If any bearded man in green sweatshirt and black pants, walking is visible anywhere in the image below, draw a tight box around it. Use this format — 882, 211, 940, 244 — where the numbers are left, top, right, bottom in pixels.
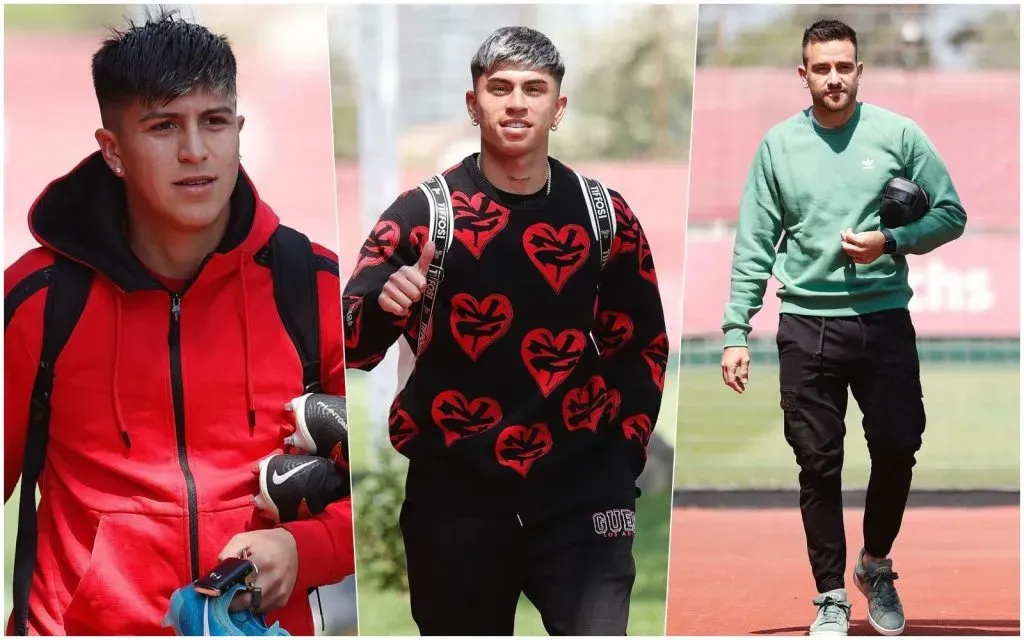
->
722, 20, 967, 635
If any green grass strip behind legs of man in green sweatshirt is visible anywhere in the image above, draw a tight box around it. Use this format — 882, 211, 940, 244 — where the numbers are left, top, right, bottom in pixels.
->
676, 362, 1020, 489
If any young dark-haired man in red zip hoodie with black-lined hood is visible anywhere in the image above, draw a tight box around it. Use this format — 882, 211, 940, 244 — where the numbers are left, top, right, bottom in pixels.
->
4, 14, 354, 635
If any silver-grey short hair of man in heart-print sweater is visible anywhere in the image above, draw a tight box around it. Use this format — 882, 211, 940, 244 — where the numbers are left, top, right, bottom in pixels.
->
469, 27, 565, 86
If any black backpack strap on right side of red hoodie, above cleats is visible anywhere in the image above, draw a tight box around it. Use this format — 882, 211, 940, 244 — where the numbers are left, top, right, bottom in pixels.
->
268, 224, 324, 393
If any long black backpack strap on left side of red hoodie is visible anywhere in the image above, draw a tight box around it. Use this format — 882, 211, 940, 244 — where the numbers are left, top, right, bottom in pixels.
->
13, 256, 92, 636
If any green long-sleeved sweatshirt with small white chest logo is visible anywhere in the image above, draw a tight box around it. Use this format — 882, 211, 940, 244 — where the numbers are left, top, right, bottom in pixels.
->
722, 102, 967, 347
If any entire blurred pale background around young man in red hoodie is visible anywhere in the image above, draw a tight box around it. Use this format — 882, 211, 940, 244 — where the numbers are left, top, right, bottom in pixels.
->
3, 4, 355, 635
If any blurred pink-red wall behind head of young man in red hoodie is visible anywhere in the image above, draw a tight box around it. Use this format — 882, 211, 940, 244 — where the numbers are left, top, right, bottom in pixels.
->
3, 33, 338, 265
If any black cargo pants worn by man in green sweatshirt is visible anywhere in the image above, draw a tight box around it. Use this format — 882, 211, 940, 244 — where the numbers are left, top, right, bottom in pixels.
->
778, 309, 925, 592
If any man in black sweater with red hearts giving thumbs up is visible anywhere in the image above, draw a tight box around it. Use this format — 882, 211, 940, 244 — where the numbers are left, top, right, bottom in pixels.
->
343, 28, 669, 635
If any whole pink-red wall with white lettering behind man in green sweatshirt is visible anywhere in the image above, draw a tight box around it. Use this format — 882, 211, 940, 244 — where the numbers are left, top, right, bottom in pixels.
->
683, 69, 1020, 338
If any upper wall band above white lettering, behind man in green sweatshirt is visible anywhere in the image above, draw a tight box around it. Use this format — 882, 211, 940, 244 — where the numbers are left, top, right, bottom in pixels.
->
689, 69, 1021, 231
